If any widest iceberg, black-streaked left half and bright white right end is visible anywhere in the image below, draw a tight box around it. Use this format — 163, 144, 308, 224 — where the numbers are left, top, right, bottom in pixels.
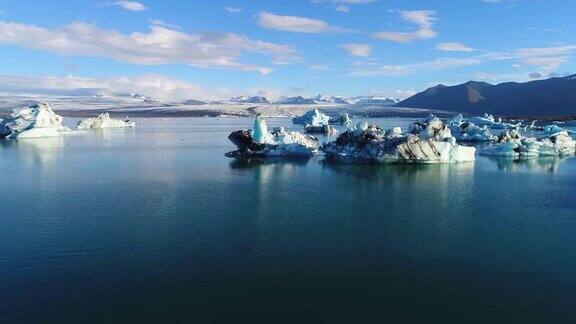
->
322, 116, 476, 164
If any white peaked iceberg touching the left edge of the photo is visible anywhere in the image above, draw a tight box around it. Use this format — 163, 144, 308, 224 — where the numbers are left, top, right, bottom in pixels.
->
0, 103, 69, 138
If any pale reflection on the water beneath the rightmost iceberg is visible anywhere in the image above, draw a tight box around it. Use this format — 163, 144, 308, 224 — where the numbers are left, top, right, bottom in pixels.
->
488, 156, 569, 173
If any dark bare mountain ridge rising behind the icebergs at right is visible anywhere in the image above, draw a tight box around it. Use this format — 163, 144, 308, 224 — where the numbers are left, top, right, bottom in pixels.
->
396, 75, 576, 116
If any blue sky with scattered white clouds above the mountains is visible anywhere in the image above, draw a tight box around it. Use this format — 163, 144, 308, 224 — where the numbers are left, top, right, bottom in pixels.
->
0, 0, 576, 100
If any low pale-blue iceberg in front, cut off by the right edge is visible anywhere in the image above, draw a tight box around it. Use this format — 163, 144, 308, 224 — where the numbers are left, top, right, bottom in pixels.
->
481, 129, 576, 158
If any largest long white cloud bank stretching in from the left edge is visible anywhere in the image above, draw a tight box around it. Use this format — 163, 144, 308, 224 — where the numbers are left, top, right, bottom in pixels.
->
0, 21, 299, 74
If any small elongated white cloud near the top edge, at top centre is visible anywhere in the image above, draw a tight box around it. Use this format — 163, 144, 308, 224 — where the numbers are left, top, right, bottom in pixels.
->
258, 12, 346, 34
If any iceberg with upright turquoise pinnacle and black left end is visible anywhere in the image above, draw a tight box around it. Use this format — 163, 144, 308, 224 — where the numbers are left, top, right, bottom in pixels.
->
226, 115, 319, 157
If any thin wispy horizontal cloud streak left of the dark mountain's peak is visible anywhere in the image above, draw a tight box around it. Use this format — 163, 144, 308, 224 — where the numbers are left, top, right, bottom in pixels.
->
350, 58, 481, 76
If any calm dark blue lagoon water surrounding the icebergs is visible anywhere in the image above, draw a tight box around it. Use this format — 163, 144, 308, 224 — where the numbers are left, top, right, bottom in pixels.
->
0, 118, 576, 323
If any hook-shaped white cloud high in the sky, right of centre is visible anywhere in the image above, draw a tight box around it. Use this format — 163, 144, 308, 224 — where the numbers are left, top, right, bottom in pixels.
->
372, 10, 438, 43
